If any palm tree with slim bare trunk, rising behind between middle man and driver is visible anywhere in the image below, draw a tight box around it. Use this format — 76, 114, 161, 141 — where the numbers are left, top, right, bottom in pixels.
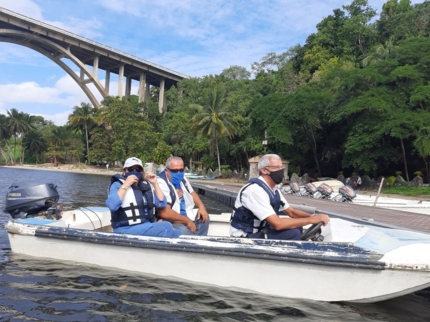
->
191, 87, 237, 173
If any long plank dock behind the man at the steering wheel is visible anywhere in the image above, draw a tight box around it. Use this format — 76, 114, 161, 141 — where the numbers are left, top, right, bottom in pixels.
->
190, 180, 430, 234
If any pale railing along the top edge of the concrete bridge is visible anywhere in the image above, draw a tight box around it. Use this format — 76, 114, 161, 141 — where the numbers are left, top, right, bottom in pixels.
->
0, 7, 189, 78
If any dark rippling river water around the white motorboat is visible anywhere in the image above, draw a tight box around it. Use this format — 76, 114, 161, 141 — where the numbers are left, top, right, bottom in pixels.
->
0, 168, 430, 322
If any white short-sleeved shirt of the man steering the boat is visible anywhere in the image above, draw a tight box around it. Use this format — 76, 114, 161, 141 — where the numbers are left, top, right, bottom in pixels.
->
230, 176, 290, 237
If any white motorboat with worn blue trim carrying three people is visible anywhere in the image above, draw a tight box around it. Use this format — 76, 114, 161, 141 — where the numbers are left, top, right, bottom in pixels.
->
6, 181, 430, 303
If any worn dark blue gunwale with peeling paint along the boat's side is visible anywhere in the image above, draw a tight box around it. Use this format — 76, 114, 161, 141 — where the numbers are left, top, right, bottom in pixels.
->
6, 220, 386, 270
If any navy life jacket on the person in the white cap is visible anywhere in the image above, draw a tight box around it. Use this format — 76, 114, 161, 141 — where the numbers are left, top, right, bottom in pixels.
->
109, 174, 155, 228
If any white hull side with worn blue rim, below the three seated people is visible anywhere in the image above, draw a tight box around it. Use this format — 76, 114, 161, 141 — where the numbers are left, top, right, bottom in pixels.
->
6, 222, 430, 303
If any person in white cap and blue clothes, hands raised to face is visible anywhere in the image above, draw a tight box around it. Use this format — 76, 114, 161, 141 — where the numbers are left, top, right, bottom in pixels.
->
106, 157, 182, 238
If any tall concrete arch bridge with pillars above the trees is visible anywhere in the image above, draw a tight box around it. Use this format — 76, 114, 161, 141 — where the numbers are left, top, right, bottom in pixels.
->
0, 7, 188, 113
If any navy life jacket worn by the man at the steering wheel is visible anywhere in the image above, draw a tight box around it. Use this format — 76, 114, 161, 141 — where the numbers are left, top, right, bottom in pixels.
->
230, 178, 285, 234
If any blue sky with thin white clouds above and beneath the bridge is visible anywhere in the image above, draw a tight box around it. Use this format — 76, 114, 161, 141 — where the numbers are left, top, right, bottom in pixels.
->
0, 0, 422, 125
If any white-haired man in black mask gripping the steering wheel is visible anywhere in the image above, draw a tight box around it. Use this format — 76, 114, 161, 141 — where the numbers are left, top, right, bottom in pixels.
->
230, 154, 330, 240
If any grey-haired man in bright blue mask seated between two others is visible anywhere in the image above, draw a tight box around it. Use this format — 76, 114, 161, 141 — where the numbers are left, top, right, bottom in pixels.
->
157, 157, 209, 236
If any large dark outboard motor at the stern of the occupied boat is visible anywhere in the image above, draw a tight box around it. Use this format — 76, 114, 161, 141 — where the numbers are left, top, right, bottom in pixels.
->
5, 181, 60, 219
